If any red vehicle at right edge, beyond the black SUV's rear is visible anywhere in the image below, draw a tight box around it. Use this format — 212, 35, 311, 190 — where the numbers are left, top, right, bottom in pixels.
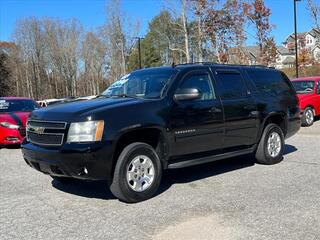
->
292, 76, 320, 126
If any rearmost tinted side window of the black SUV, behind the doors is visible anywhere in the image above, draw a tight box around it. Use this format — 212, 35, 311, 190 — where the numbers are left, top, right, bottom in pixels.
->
247, 69, 291, 94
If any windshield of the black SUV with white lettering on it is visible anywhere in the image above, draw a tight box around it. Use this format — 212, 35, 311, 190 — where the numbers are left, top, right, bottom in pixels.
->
101, 69, 177, 98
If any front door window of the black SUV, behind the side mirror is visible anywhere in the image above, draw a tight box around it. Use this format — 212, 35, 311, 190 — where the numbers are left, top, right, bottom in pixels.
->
179, 74, 215, 100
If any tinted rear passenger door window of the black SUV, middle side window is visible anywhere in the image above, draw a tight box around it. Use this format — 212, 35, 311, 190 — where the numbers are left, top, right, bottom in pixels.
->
217, 72, 247, 99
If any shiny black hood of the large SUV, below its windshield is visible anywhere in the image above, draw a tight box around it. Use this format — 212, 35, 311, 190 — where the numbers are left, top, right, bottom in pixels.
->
31, 97, 144, 122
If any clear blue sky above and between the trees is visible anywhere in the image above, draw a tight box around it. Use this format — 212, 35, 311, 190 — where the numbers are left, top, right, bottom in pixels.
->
0, 0, 320, 45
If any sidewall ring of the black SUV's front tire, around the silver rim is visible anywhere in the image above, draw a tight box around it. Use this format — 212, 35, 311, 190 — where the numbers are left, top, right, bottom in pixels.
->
116, 143, 162, 202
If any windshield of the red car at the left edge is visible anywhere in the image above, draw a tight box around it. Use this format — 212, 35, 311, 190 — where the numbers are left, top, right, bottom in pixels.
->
0, 99, 38, 113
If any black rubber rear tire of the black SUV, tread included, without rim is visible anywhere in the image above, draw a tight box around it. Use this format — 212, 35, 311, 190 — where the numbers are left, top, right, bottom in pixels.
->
255, 123, 284, 165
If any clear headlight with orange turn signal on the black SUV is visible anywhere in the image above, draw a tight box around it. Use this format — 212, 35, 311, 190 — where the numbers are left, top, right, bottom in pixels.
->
67, 121, 104, 143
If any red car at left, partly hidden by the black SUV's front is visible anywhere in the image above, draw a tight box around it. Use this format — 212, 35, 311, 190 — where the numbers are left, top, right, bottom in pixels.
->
0, 97, 39, 146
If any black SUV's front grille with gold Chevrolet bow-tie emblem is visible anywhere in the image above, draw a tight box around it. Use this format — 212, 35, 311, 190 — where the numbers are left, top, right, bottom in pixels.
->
27, 120, 67, 146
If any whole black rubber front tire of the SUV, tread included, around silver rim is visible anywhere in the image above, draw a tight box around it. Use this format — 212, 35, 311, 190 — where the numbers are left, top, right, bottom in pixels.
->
110, 142, 162, 203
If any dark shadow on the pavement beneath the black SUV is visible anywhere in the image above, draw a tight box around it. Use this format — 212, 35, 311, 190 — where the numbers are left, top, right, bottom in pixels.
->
51, 144, 297, 200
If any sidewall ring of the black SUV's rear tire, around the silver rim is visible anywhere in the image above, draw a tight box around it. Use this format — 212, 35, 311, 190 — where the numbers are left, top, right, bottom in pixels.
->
263, 124, 284, 164
